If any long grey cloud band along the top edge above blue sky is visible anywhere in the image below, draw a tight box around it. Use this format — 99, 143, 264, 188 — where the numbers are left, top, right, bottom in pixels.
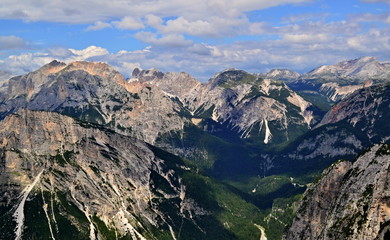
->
0, 0, 311, 24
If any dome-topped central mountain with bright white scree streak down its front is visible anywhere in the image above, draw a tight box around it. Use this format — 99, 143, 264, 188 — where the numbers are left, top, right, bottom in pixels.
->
185, 69, 314, 144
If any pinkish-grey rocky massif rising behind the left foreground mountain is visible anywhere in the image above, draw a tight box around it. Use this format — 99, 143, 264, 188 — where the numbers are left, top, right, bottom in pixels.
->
0, 62, 189, 143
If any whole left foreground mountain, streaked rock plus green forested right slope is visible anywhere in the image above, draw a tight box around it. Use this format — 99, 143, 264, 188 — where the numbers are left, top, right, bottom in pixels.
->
0, 110, 261, 240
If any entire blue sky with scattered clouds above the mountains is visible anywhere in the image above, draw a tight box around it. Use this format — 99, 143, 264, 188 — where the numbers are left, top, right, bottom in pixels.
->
0, 0, 390, 81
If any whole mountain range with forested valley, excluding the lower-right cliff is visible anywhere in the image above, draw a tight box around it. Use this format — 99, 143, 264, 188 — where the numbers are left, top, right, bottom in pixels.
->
0, 57, 390, 239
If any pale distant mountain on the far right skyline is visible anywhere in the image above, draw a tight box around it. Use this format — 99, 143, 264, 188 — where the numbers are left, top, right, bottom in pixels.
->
288, 57, 390, 103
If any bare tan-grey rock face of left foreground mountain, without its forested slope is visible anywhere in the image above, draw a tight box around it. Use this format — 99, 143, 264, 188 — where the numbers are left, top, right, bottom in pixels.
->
0, 110, 203, 239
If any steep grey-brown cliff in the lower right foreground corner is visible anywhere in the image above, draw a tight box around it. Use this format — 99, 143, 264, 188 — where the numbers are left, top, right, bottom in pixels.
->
285, 144, 390, 239
